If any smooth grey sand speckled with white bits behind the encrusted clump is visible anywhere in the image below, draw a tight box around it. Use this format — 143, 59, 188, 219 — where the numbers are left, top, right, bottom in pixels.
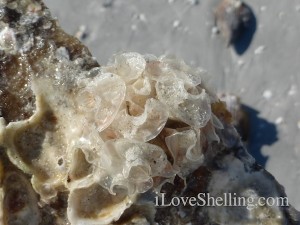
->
46, 0, 300, 210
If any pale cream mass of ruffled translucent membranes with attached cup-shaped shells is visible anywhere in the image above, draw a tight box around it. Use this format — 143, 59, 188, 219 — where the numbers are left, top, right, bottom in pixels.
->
2, 50, 222, 224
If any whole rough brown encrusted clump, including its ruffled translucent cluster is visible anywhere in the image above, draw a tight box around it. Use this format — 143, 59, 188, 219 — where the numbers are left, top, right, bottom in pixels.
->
0, 0, 300, 225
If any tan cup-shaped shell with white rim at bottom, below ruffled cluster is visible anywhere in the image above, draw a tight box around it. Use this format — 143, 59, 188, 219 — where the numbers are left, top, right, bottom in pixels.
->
67, 184, 135, 225
